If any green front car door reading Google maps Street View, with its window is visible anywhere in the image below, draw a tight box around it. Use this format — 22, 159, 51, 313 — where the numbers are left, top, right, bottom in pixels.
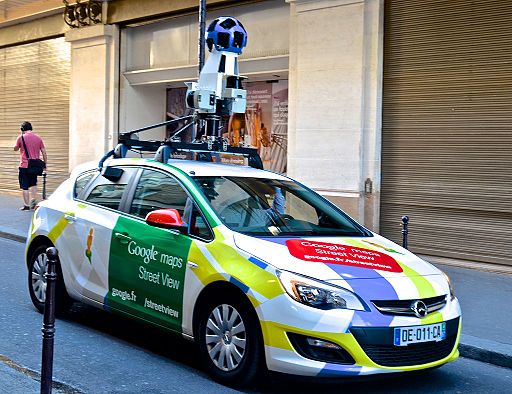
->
108, 169, 192, 332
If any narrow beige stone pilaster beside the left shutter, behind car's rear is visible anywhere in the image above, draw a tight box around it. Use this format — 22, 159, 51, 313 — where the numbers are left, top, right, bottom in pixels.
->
66, 25, 119, 170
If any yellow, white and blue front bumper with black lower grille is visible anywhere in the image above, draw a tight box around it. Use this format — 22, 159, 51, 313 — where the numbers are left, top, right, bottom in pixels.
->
261, 300, 461, 377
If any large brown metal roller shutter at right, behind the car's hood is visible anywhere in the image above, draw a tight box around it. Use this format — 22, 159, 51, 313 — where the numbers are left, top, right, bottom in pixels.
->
381, 0, 512, 265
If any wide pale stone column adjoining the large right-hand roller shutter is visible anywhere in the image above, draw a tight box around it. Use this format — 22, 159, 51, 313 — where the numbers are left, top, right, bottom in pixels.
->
287, 0, 383, 229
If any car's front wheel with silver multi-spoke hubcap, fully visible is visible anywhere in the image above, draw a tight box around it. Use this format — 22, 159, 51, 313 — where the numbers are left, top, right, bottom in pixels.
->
197, 294, 264, 387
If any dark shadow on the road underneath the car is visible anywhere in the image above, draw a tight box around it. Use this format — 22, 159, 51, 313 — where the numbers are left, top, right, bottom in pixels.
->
59, 303, 456, 394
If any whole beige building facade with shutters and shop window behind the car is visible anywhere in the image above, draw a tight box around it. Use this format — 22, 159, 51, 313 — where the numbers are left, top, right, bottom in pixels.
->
0, 0, 512, 265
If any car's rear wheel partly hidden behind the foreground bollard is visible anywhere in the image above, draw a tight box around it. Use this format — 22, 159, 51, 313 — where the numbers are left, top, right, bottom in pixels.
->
28, 244, 73, 315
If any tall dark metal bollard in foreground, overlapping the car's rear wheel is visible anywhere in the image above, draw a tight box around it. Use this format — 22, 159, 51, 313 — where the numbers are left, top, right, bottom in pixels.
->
41, 247, 59, 394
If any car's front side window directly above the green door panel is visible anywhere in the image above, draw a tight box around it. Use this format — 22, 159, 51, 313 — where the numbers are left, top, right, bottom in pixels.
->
129, 169, 188, 222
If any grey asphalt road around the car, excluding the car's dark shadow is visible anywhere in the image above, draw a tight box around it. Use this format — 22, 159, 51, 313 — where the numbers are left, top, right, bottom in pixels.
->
0, 239, 512, 393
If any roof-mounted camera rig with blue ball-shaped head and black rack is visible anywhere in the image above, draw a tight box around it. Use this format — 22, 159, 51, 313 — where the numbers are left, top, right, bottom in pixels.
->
99, 17, 263, 169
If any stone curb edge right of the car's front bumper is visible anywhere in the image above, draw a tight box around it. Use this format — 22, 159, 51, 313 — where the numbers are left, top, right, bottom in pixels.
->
459, 334, 512, 369
